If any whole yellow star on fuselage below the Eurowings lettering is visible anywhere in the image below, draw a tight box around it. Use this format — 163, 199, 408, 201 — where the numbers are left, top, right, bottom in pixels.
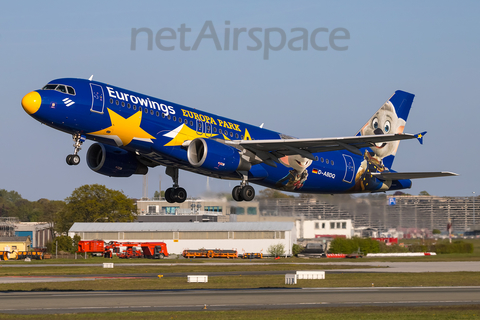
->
89, 109, 155, 146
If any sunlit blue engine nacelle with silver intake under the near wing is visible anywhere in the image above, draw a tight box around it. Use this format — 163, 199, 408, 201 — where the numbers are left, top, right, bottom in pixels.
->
187, 138, 252, 173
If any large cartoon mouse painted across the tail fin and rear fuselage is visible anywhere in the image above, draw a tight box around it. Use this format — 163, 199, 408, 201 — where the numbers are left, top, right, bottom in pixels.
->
354, 101, 405, 191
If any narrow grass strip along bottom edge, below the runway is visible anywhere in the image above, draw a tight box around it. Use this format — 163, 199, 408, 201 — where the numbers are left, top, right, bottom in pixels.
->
0, 305, 480, 320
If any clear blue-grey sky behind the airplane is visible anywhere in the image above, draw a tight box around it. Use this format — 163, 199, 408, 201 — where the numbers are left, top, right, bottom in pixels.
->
0, 1, 480, 201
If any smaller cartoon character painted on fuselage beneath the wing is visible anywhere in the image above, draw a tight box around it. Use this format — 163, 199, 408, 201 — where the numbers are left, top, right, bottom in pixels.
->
275, 154, 312, 191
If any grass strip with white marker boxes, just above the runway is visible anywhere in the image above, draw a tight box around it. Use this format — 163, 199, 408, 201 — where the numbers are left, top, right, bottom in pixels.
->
1, 272, 480, 291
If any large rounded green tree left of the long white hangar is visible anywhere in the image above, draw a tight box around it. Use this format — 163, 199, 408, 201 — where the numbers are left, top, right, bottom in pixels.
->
55, 184, 135, 233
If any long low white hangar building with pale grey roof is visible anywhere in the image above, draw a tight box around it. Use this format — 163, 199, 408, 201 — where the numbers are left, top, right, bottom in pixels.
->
68, 222, 297, 255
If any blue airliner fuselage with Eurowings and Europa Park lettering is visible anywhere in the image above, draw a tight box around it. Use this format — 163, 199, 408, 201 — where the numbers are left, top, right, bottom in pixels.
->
23, 78, 411, 193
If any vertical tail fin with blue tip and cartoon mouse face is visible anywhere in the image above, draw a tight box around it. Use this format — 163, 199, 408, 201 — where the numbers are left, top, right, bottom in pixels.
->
357, 90, 415, 169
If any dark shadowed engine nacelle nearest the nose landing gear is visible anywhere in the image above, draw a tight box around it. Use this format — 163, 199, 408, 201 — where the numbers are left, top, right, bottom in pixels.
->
87, 143, 148, 177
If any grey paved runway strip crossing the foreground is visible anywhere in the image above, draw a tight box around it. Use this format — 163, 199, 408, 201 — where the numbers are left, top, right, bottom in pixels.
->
0, 287, 480, 314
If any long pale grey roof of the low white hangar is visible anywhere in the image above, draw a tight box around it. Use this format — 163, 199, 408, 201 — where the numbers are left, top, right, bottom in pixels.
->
69, 222, 294, 232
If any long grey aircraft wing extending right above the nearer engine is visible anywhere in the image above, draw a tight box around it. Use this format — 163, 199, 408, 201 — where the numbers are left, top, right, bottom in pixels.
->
226, 133, 418, 167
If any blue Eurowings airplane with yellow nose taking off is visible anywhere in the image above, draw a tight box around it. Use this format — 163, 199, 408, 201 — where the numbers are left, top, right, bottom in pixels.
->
22, 76, 456, 203
